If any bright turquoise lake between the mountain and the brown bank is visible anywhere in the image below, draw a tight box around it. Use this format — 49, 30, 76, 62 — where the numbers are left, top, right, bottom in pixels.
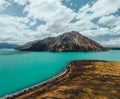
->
0, 49, 120, 97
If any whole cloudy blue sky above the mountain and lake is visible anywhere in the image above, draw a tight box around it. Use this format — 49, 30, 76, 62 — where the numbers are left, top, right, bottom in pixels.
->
0, 0, 120, 46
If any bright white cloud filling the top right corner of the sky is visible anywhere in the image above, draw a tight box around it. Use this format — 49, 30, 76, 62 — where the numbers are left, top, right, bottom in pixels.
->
90, 0, 120, 17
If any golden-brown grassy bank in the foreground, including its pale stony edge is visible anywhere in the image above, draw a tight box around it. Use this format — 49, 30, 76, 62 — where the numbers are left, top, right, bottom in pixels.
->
3, 60, 120, 99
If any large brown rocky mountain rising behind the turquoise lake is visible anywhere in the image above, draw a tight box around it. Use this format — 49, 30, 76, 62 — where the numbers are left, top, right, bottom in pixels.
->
17, 31, 108, 52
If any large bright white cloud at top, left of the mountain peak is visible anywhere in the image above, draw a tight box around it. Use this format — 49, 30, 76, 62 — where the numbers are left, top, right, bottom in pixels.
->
24, 0, 76, 37
